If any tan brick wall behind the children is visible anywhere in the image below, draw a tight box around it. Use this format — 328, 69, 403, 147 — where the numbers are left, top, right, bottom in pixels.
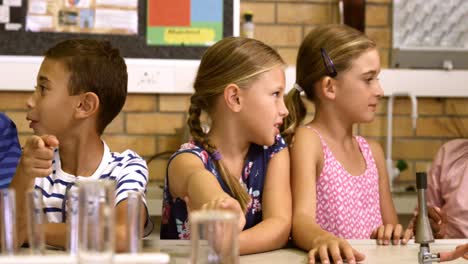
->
0, 0, 468, 187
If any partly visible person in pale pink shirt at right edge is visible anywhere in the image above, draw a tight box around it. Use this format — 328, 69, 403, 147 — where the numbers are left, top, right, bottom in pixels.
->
403, 139, 468, 242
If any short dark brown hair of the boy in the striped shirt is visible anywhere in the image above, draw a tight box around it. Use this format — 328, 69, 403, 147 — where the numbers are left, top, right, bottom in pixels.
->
44, 39, 128, 134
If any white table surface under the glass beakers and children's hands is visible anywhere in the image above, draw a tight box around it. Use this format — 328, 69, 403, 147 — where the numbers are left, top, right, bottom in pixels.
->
0, 239, 468, 264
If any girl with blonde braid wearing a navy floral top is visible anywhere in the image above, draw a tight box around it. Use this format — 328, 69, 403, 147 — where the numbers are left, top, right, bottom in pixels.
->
161, 37, 291, 254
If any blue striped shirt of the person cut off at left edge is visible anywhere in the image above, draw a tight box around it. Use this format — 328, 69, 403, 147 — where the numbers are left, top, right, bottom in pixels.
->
0, 113, 21, 189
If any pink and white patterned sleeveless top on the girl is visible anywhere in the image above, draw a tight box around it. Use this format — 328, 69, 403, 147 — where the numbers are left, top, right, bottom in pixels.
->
309, 127, 382, 239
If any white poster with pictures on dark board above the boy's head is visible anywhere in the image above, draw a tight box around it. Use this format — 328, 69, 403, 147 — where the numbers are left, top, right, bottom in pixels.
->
26, 0, 138, 35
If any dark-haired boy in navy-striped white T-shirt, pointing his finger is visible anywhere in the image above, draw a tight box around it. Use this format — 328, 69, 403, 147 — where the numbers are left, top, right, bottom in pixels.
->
11, 39, 152, 251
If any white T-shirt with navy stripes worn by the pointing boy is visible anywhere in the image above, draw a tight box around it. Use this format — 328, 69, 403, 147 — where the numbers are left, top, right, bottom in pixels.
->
35, 143, 153, 235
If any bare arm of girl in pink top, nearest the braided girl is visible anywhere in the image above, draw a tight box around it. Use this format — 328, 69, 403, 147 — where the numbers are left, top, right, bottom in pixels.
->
290, 127, 364, 263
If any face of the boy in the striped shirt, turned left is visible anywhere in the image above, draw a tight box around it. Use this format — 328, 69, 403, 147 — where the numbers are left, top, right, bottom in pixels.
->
26, 58, 79, 136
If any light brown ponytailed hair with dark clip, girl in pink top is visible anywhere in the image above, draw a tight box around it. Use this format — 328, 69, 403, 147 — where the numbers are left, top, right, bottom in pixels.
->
282, 24, 376, 142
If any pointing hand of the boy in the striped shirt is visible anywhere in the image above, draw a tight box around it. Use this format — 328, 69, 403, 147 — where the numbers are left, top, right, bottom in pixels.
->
19, 135, 59, 178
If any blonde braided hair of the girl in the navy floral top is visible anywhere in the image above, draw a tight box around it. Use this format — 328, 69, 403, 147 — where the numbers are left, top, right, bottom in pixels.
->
187, 37, 284, 210
